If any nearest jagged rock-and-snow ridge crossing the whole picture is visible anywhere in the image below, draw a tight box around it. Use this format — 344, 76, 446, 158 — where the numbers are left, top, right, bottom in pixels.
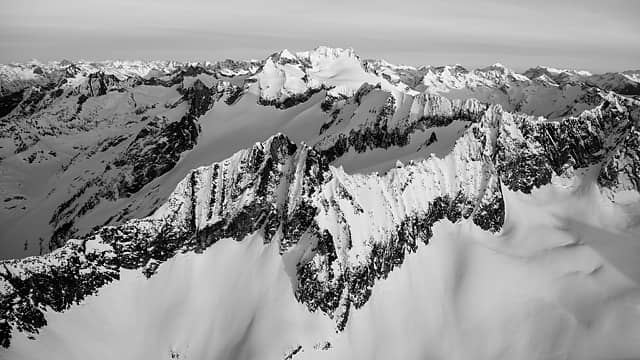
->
0, 95, 640, 347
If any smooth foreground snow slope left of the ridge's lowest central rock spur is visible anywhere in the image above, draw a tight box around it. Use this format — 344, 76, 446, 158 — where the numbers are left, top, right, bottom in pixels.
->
0, 235, 333, 360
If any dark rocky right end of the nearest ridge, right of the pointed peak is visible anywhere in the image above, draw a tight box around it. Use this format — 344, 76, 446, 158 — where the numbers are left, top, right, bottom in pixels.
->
497, 96, 638, 193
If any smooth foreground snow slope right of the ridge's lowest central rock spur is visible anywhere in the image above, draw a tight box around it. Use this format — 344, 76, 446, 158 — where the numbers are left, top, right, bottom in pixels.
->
308, 181, 640, 360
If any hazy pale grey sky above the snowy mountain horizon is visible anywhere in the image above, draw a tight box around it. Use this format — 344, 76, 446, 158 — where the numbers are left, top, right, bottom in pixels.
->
0, 0, 640, 71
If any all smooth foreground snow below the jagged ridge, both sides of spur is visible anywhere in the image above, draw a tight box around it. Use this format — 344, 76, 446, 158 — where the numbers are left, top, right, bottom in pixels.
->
3, 175, 640, 360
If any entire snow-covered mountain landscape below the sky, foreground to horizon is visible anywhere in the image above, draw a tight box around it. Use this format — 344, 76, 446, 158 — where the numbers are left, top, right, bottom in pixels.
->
0, 47, 640, 359
